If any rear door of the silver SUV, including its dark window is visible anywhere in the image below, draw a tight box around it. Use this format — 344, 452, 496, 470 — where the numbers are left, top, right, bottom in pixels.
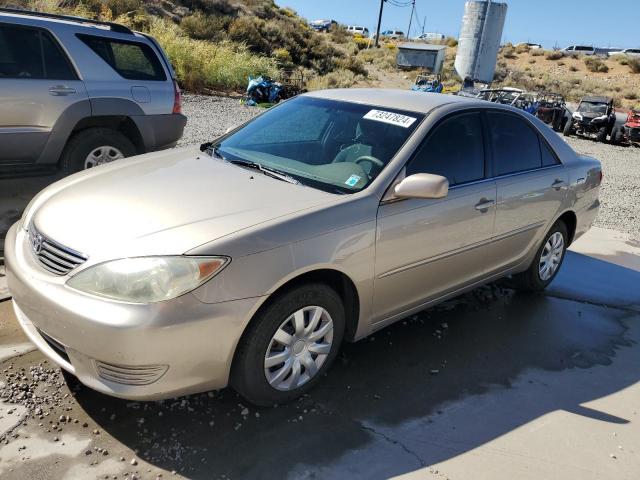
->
0, 23, 91, 165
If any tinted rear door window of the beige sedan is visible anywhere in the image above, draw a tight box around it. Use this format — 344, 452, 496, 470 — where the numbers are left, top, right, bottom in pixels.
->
487, 112, 542, 176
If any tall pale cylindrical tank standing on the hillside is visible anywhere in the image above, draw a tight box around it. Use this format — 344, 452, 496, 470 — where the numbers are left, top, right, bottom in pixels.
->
455, 1, 507, 83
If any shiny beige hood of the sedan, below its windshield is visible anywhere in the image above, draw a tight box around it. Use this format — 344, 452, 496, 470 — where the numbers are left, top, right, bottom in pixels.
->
32, 149, 339, 263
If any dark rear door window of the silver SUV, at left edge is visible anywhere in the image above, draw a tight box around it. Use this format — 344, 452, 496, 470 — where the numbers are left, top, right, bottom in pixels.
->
0, 24, 77, 80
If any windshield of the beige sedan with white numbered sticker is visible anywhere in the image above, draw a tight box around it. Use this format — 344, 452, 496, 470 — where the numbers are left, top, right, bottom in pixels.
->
214, 96, 423, 193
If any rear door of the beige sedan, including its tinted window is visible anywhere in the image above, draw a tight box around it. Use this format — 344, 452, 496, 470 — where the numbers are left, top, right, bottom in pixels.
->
485, 111, 568, 270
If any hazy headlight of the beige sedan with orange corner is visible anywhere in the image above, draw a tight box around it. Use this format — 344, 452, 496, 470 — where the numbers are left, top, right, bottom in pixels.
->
67, 256, 230, 303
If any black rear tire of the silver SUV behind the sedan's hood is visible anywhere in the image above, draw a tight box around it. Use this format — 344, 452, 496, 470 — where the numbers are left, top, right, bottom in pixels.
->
61, 128, 137, 175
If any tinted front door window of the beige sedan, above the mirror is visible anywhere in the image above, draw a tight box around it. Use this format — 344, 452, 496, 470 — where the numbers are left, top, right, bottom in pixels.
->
407, 113, 484, 185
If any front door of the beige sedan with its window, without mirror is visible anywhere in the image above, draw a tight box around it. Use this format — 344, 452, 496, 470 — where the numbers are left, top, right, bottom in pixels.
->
373, 112, 496, 323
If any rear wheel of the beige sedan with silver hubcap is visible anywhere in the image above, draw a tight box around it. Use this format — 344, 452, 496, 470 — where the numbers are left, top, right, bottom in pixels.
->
510, 220, 569, 292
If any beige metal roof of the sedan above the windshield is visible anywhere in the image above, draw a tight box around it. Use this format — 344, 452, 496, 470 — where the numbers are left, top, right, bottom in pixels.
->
304, 88, 472, 113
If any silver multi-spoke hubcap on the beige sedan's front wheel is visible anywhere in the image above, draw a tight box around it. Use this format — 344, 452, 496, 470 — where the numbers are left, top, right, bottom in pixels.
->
264, 306, 333, 391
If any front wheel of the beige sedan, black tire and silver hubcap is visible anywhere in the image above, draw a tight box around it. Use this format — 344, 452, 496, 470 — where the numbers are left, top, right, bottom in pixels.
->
230, 283, 345, 406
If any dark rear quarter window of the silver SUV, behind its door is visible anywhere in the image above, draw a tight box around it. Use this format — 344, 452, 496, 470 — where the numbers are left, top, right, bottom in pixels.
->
78, 35, 167, 81
